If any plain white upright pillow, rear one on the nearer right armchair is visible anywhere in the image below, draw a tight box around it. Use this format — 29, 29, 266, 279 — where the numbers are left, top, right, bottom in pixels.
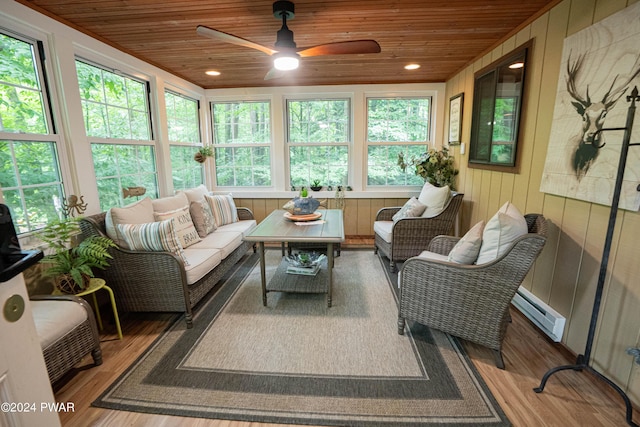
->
476, 202, 529, 264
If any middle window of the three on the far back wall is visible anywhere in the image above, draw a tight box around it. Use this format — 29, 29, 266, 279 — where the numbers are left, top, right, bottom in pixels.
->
287, 99, 351, 187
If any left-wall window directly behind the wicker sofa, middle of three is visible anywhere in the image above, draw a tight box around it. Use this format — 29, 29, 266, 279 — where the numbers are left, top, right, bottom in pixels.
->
76, 60, 158, 210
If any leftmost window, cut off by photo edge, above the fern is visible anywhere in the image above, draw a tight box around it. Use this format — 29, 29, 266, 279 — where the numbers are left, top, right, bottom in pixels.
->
0, 32, 64, 233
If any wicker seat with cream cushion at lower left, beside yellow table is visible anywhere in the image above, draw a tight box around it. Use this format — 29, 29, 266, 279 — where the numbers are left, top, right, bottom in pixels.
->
29, 295, 102, 384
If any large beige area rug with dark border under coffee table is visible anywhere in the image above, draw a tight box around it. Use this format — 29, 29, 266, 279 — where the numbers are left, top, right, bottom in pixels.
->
93, 250, 510, 426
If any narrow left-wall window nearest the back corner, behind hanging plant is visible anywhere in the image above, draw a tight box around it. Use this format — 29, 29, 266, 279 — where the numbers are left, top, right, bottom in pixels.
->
164, 90, 204, 190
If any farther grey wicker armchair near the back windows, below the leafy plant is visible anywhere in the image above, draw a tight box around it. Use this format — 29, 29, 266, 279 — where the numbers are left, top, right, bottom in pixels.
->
374, 193, 464, 272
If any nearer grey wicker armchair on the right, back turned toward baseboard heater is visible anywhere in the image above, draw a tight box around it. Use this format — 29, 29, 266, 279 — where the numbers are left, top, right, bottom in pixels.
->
398, 214, 547, 369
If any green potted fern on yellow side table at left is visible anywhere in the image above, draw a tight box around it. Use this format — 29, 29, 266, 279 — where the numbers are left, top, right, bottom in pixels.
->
37, 218, 116, 294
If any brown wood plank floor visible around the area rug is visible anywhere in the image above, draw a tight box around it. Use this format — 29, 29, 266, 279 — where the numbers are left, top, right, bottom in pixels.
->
54, 242, 640, 427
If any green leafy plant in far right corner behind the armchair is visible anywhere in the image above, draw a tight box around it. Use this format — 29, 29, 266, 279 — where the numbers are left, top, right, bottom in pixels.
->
398, 147, 458, 190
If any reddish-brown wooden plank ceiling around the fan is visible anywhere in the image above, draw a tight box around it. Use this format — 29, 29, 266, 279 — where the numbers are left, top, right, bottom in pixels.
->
17, 0, 559, 89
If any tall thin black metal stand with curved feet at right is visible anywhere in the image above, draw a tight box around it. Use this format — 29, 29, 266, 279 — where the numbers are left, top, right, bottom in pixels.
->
533, 86, 640, 427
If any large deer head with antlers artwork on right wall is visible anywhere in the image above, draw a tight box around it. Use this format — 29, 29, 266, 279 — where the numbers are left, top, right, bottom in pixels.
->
540, 3, 640, 210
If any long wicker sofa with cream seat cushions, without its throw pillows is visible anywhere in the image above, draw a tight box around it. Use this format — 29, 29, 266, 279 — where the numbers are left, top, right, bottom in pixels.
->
80, 189, 256, 328
